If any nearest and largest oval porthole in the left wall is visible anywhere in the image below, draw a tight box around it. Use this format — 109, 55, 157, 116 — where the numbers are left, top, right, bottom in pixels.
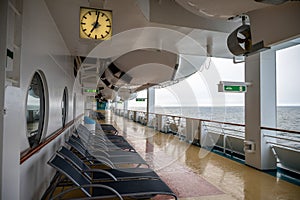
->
26, 72, 45, 148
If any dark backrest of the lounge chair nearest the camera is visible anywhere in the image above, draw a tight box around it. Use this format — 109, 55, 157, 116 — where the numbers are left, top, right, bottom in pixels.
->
48, 154, 91, 197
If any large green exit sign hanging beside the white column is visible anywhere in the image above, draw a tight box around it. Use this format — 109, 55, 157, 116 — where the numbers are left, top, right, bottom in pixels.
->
218, 81, 249, 93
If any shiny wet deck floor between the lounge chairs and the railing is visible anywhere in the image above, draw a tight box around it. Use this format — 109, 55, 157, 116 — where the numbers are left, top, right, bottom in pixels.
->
105, 113, 300, 200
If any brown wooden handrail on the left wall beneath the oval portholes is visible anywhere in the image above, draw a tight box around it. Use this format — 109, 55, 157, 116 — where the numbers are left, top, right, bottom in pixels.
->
20, 114, 83, 164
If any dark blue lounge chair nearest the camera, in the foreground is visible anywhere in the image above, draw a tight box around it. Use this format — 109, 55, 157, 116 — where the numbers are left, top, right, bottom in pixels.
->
48, 154, 177, 199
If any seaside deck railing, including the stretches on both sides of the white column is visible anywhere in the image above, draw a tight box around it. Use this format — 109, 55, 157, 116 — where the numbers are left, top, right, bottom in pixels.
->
114, 109, 300, 173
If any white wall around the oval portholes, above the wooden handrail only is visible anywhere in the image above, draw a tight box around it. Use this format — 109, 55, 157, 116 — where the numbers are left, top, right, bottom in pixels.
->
20, 0, 74, 151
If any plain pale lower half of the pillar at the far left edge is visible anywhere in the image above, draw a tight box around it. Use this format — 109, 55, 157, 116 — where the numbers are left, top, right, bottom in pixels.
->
0, 86, 22, 199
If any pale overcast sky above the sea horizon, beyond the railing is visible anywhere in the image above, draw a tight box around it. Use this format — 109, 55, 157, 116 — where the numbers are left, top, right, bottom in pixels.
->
130, 45, 300, 107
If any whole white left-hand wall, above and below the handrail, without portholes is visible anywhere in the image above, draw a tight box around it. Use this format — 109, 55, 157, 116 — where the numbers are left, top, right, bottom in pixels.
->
2, 0, 83, 199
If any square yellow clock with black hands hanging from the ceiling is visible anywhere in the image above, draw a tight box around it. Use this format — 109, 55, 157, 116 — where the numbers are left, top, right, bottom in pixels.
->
79, 7, 112, 40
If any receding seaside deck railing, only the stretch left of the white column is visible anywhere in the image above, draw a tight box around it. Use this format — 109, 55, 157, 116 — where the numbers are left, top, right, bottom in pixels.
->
114, 109, 245, 158
